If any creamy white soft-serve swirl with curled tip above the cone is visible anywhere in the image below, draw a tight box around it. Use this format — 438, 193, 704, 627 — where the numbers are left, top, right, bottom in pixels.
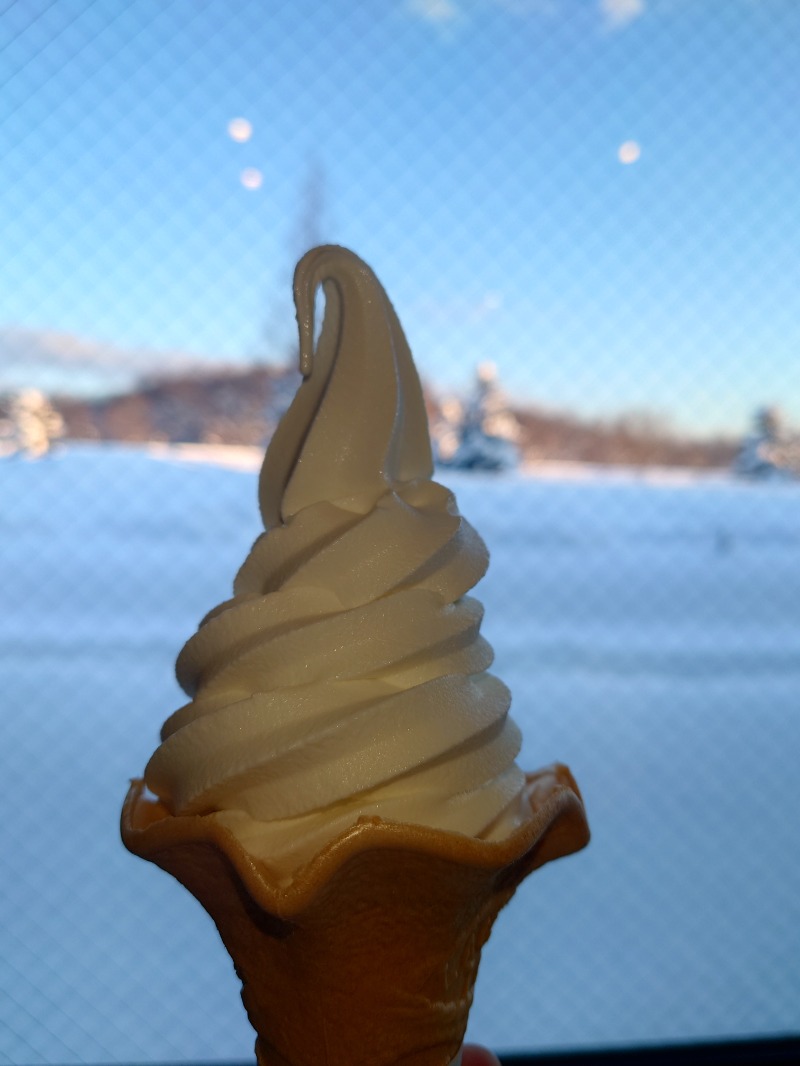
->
145, 246, 526, 876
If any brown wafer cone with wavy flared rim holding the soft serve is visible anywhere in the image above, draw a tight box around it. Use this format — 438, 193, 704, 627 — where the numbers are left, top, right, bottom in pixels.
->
122, 765, 589, 1066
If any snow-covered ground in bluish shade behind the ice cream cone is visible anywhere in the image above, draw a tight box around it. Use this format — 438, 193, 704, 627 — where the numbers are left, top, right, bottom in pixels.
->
0, 447, 800, 1064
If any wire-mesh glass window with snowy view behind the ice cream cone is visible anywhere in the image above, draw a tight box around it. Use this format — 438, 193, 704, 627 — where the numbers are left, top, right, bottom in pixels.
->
0, 0, 800, 1064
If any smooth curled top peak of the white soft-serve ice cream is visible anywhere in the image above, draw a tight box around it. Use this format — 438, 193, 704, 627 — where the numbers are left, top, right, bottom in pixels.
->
259, 245, 433, 529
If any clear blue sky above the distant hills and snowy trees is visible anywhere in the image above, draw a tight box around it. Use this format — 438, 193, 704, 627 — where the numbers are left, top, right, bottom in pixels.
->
0, 0, 800, 433
